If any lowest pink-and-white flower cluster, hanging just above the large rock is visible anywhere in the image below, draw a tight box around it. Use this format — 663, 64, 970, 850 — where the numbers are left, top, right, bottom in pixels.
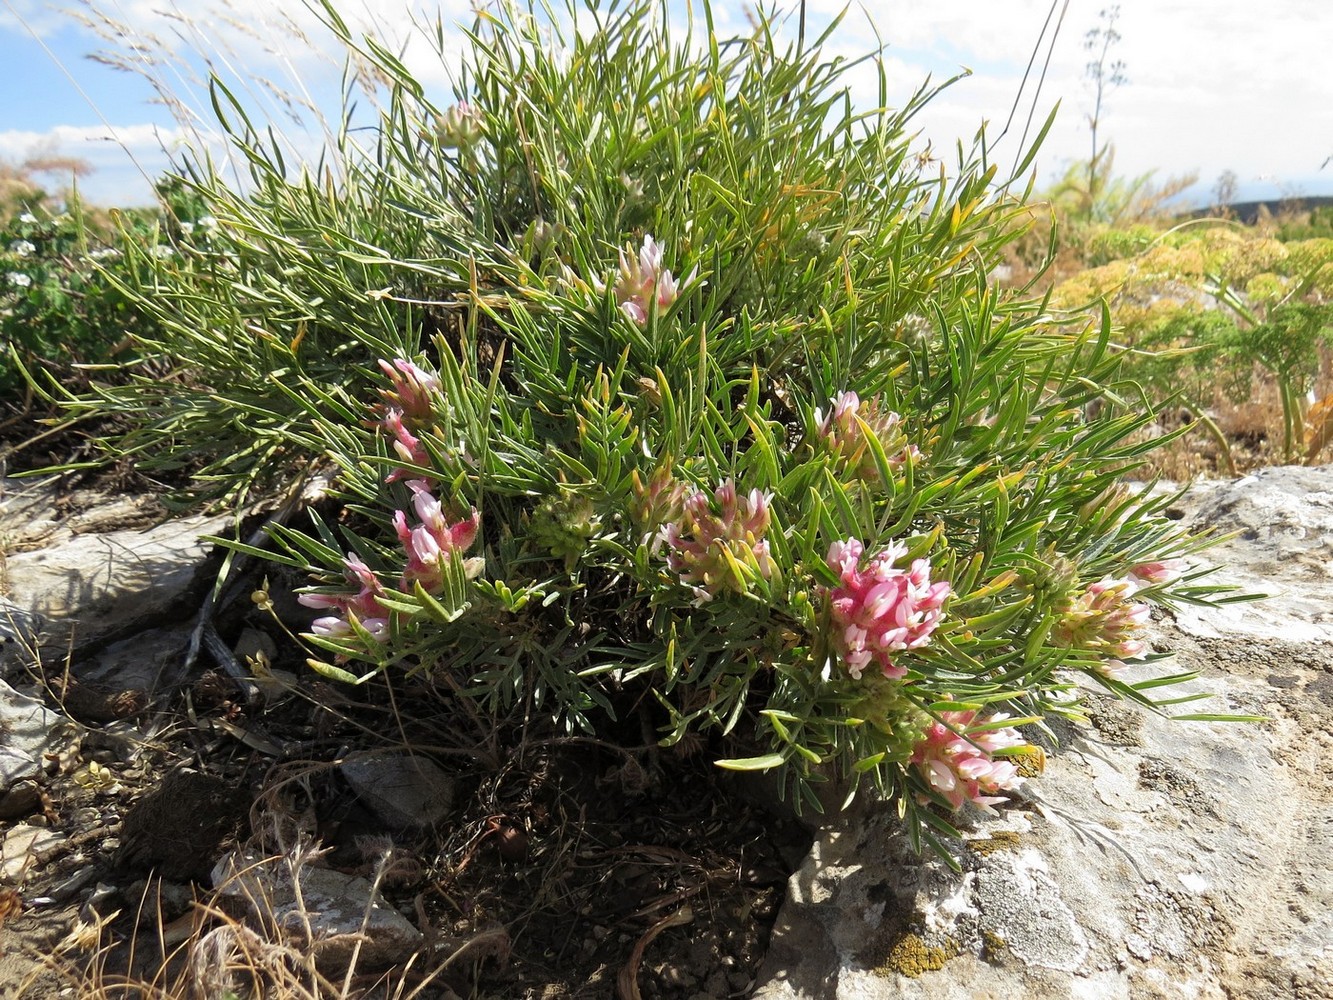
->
912, 711, 1026, 815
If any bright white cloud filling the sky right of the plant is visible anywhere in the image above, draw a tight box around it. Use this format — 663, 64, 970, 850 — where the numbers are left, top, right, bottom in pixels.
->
810, 0, 1333, 193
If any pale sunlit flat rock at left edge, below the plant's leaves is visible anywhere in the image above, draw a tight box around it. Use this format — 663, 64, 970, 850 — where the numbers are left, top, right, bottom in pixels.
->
0, 477, 228, 661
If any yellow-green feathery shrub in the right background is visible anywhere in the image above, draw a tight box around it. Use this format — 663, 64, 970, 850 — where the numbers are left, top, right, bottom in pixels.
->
1052, 221, 1333, 471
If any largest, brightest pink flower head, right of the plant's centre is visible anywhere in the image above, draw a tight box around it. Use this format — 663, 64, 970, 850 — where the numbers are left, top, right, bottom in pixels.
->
828, 539, 952, 680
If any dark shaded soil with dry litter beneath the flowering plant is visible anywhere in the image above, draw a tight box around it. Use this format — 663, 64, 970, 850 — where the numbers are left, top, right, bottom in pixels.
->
0, 498, 810, 1000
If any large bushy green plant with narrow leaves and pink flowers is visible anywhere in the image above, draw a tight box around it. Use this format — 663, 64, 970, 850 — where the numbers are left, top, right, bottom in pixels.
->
75, 1, 1247, 844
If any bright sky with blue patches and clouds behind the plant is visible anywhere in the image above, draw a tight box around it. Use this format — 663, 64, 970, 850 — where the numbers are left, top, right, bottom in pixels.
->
0, 0, 1333, 204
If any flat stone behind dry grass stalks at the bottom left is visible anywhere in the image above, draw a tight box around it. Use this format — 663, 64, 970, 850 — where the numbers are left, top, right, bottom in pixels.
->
213, 853, 423, 975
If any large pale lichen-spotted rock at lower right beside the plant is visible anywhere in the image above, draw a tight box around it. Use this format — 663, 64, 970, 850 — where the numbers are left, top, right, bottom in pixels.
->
754, 468, 1333, 1000
